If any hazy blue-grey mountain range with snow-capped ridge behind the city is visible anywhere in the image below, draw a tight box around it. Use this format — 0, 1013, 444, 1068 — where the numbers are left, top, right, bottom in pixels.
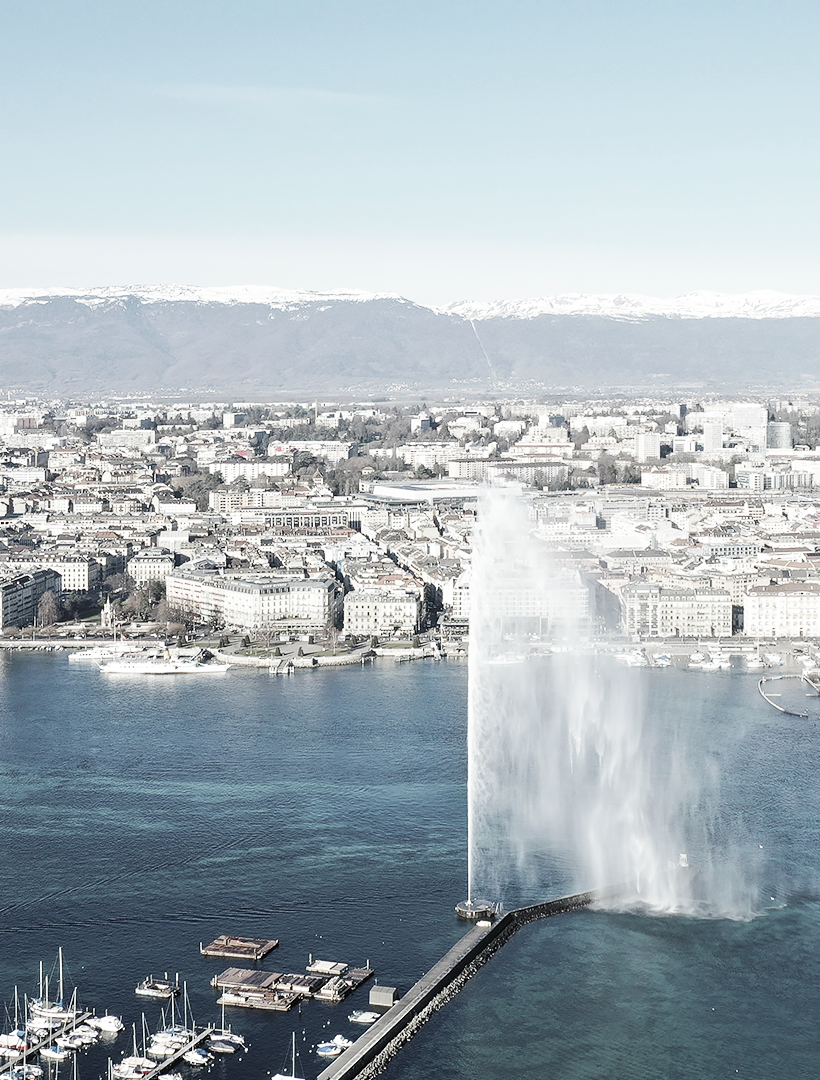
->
0, 286, 820, 396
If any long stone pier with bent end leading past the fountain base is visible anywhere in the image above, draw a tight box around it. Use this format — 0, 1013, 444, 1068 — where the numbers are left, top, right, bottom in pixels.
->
318, 887, 628, 1080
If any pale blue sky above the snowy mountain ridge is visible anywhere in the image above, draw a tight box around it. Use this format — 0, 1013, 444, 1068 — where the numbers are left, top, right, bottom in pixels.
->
0, 0, 820, 305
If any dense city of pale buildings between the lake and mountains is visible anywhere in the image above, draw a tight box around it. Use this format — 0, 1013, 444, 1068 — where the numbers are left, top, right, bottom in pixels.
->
0, 397, 820, 663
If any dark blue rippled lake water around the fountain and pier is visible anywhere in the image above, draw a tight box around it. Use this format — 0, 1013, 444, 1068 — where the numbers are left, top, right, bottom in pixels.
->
0, 653, 820, 1080
